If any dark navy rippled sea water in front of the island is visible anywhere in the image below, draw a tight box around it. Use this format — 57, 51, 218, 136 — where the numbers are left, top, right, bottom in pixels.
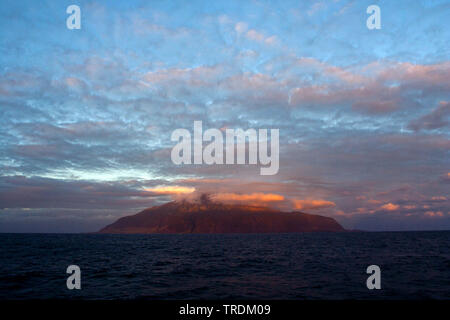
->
0, 232, 450, 299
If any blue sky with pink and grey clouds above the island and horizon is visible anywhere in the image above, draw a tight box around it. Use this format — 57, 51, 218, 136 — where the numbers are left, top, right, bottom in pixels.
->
0, 0, 450, 232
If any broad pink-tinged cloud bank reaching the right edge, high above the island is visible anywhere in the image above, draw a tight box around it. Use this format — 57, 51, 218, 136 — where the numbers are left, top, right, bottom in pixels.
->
289, 59, 450, 115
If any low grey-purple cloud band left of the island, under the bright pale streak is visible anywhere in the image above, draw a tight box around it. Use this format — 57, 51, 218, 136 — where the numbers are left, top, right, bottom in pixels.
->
0, 176, 160, 211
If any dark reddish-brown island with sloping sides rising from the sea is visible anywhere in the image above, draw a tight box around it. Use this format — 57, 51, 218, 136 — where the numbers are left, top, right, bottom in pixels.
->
98, 200, 346, 234
